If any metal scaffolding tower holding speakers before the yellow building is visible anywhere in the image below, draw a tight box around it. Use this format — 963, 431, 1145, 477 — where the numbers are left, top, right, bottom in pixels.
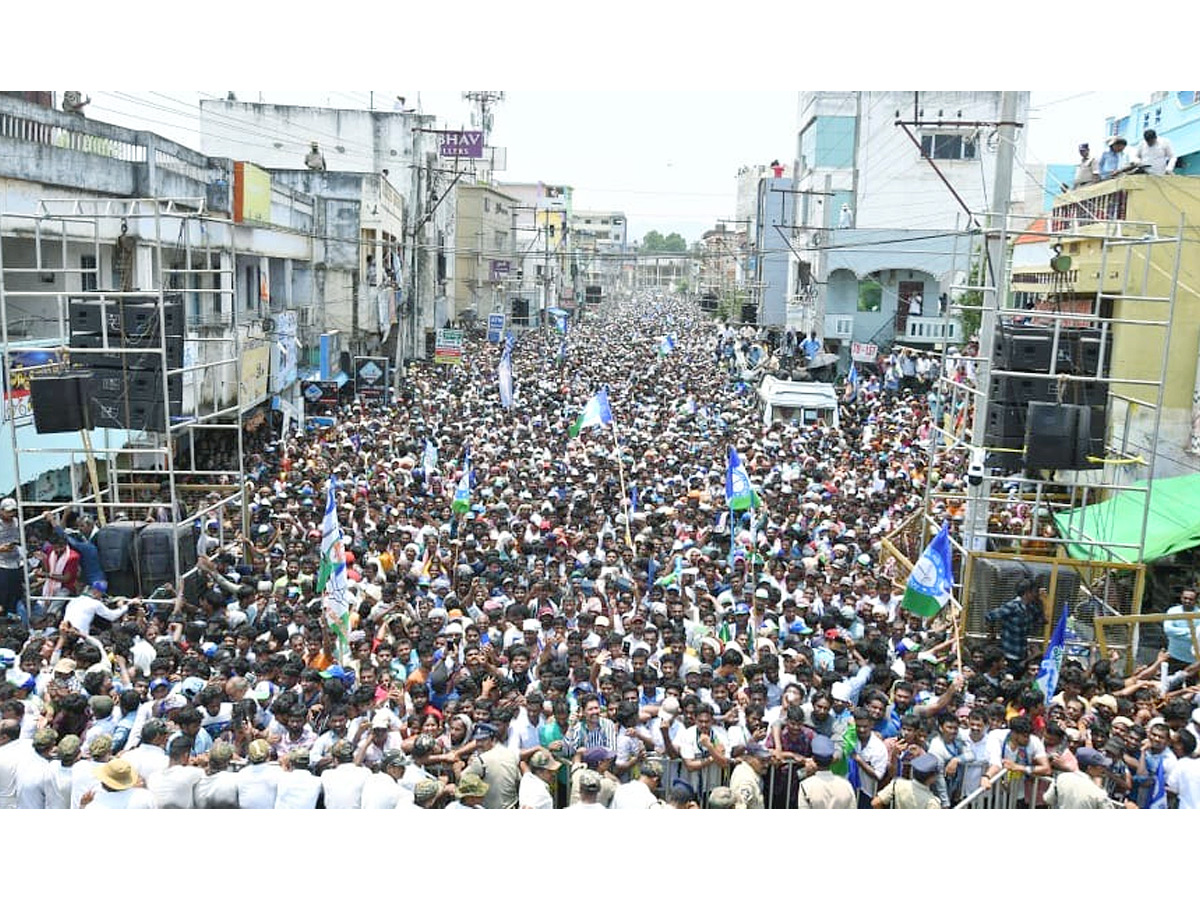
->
912, 205, 1184, 655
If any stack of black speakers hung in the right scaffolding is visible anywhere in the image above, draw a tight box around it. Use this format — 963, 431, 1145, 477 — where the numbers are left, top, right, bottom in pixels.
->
985, 324, 1110, 472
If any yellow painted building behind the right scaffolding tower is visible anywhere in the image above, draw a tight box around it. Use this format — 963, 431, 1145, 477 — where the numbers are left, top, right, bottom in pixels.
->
1010, 175, 1200, 480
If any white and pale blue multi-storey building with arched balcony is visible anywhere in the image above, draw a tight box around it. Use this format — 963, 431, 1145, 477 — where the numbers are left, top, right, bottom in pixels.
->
787, 91, 1042, 355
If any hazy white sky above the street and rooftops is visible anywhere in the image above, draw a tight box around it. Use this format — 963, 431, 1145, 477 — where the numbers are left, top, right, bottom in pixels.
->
89, 85, 1151, 241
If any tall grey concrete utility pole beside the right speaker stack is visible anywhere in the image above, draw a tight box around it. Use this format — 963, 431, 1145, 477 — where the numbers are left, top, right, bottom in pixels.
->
964, 91, 1018, 551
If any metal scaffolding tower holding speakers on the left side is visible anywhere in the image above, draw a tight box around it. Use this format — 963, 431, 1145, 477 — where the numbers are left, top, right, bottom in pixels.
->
0, 198, 246, 602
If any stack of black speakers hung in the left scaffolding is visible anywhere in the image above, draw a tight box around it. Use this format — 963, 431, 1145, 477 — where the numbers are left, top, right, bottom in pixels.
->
32, 298, 184, 433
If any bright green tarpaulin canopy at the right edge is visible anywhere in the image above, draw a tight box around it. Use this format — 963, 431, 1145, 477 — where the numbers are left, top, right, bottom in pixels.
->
1054, 474, 1200, 563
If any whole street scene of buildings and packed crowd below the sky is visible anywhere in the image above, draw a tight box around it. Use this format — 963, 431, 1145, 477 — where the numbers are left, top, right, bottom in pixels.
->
0, 91, 1200, 809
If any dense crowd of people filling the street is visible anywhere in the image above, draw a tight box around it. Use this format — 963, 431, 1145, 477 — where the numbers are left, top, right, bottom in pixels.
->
0, 295, 1200, 810
